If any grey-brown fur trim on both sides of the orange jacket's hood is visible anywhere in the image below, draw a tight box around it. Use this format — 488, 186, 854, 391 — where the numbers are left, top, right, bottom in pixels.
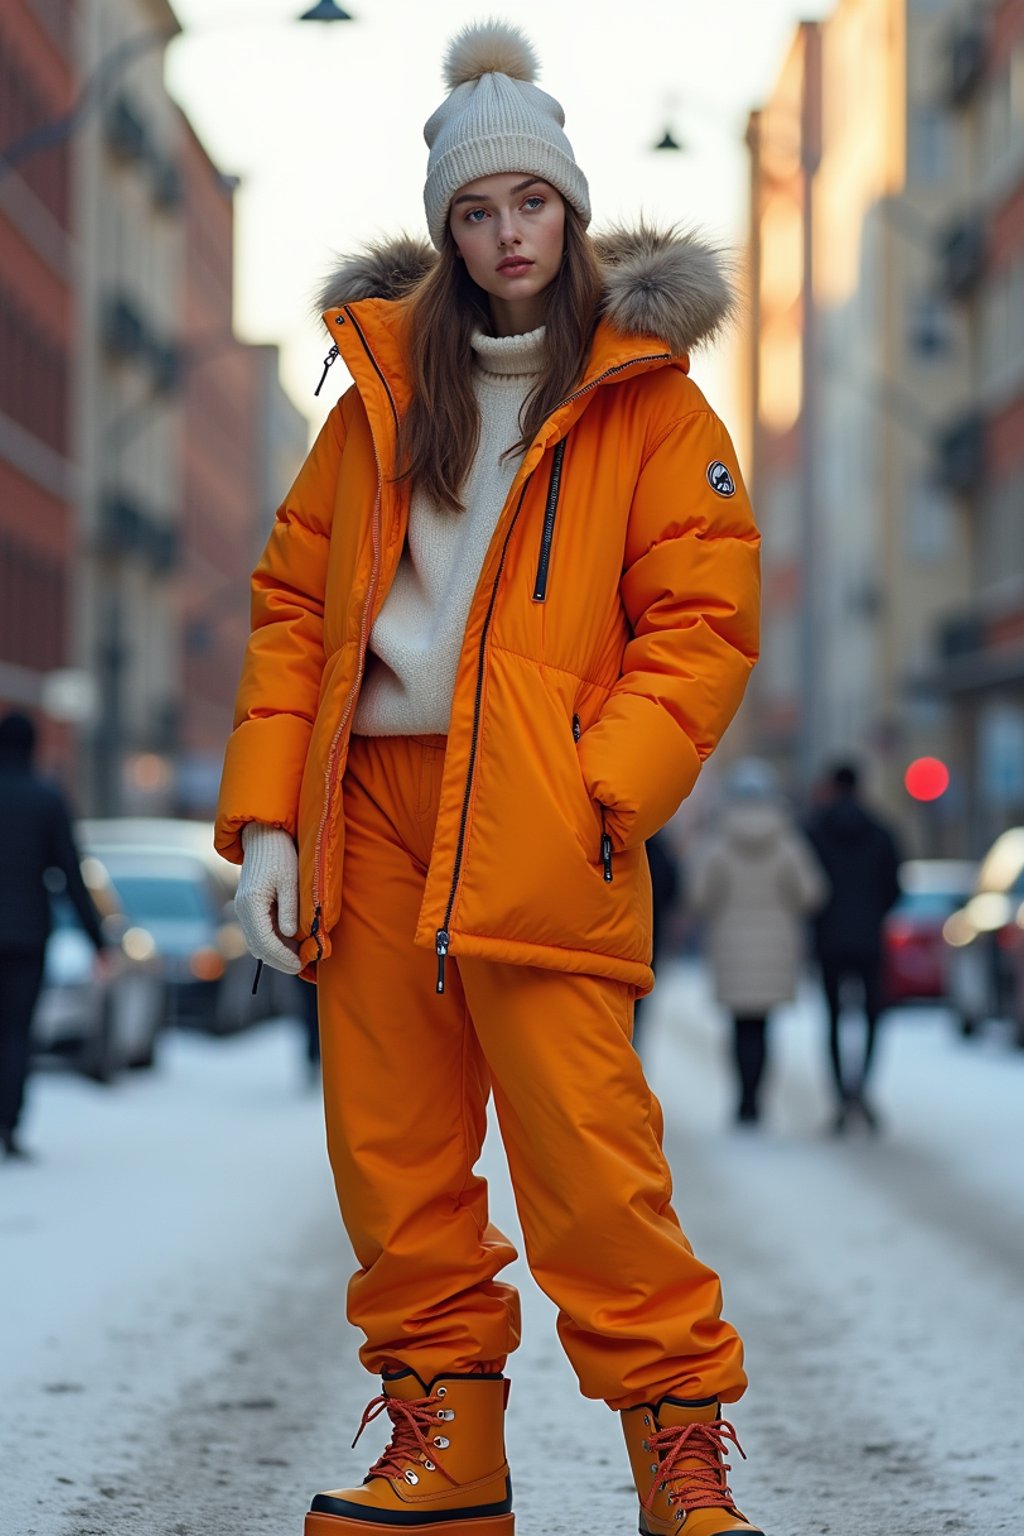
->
319, 224, 735, 356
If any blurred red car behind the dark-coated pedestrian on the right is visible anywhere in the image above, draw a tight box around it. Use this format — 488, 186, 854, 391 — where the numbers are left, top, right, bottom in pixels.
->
883, 859, 976, 1008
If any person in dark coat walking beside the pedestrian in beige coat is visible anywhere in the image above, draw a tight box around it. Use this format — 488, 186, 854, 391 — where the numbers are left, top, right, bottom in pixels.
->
808, 763, 900, 1130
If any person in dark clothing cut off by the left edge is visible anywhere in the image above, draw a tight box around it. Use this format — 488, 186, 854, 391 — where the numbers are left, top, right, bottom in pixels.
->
0, 713, 104, 1157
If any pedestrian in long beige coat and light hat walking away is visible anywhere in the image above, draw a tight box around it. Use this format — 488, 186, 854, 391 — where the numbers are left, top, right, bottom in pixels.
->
691, 757, 827, 1124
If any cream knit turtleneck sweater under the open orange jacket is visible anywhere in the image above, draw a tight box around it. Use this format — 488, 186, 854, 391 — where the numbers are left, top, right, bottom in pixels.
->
352, 326, 545, 736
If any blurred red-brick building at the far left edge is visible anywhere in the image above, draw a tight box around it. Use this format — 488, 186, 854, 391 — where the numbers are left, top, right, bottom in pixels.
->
0, 0, 77, 780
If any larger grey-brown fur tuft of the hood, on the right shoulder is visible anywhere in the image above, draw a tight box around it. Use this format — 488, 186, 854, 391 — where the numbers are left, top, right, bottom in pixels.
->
594, 224, 735, 353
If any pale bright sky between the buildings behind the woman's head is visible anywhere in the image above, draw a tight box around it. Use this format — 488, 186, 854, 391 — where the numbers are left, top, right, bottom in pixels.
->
167, 0, 832, 421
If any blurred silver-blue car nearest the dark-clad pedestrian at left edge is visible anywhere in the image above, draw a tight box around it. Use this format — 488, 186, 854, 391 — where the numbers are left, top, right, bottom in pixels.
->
32, 857, 164, 1083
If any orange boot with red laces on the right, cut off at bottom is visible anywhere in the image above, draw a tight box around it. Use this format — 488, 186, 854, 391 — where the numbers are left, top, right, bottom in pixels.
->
622, 1398, 763, 1536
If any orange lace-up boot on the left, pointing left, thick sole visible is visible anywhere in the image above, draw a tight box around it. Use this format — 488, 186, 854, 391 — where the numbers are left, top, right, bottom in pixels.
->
306, 1370, 514, 1536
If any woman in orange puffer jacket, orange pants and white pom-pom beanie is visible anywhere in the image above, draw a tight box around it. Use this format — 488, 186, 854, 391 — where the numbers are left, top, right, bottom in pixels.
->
216, 23, 758, 1536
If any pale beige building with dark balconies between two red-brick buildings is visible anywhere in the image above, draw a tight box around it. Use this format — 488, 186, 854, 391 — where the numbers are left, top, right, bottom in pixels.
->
74, 0, 184, 813
